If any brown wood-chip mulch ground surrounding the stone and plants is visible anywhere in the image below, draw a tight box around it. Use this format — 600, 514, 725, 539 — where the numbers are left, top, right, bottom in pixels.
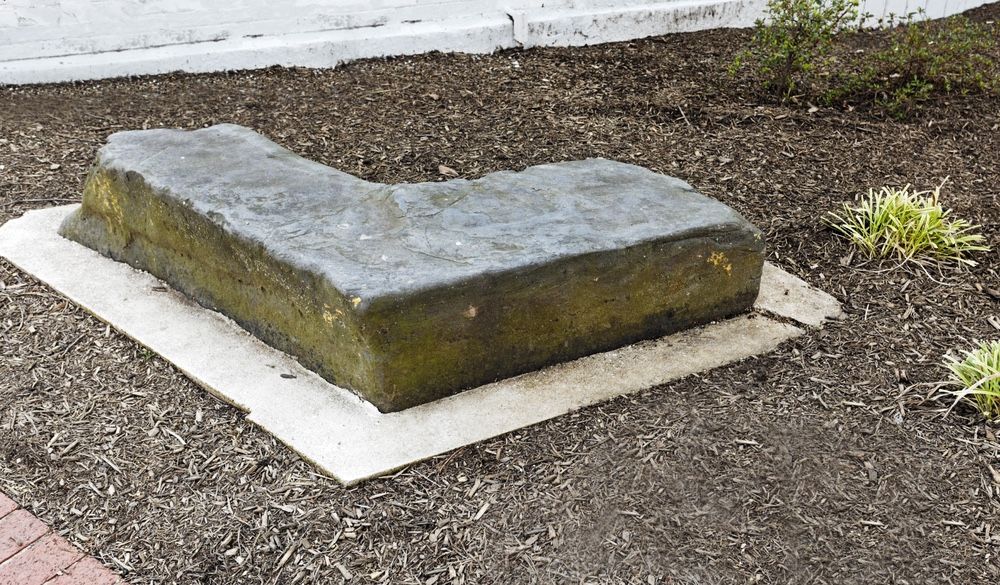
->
0, 5, 1000, 585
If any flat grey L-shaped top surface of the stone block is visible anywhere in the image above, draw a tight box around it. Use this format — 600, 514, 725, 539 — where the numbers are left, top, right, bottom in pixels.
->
99, 124, 756, 310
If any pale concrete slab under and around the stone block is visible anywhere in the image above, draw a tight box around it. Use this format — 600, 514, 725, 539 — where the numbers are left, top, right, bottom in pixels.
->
0, 205, 840, 484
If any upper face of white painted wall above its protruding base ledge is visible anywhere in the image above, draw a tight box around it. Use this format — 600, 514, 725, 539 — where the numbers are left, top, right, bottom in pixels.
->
0, 0, 508, 61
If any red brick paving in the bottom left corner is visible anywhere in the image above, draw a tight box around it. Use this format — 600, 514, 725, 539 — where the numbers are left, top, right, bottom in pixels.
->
0, 493, 125, 585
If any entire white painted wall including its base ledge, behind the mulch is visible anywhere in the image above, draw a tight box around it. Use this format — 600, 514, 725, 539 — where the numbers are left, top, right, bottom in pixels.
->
0, 0, 987, 83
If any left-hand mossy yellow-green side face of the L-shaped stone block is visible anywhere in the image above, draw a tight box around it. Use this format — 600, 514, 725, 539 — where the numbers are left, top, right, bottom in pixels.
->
61, 166, 379, 391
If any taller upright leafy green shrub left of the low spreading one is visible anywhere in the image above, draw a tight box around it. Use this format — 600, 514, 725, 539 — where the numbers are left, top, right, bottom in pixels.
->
730, 0, 860, 100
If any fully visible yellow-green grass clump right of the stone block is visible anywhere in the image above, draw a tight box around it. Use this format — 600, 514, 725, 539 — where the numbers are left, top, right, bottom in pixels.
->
826, 185, 989, 266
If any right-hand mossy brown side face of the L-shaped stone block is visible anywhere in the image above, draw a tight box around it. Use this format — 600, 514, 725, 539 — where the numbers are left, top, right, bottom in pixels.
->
364, 233, 761, 407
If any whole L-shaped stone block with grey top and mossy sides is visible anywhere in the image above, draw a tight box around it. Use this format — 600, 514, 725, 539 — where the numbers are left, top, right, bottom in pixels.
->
61, 125, 763, 411
